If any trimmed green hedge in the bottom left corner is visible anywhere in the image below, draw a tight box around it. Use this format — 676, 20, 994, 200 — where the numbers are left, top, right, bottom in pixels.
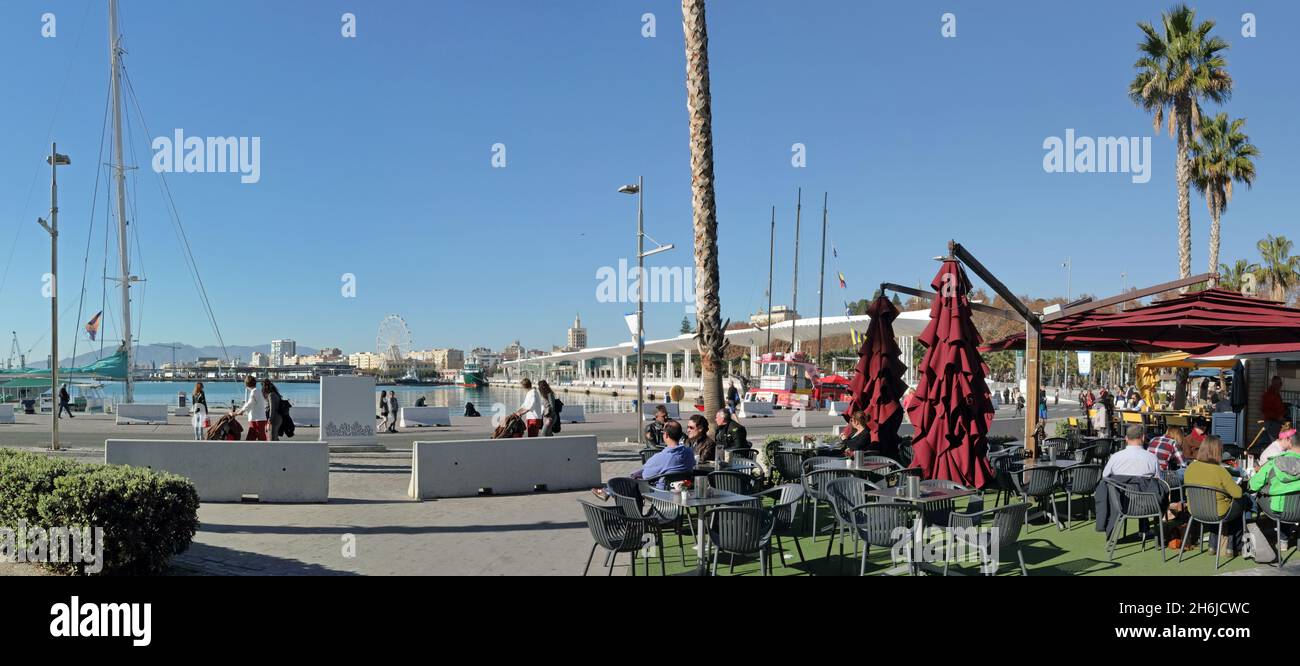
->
0, 449, 199, 575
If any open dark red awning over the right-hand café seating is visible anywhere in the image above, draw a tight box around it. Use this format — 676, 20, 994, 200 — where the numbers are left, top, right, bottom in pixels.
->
983, 289, 1300, 356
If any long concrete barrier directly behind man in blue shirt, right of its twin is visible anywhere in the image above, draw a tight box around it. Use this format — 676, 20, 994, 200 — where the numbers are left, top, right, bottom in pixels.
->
407, 434, 601, 500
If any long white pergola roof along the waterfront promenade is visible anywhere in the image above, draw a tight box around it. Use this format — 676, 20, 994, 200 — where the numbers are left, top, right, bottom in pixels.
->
503, 310, 930, 366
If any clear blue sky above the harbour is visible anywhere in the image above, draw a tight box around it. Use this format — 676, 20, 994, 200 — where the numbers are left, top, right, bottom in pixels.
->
0, 0, 1300, 354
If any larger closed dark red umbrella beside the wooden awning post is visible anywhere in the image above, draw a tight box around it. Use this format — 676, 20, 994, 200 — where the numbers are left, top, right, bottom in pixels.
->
907, 259, 993, 488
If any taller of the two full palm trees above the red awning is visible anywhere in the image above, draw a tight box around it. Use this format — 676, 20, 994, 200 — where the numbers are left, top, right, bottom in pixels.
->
1128, 5, 1232, 284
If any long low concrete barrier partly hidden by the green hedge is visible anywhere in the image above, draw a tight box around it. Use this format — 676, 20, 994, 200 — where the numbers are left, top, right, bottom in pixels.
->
104, 440, 329, 502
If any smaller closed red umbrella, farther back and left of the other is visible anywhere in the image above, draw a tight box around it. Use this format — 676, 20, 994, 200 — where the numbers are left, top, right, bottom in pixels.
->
844, 295, 907, 458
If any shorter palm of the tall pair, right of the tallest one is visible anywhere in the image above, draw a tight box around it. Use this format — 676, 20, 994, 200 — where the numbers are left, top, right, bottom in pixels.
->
1192, 113, 1260, 280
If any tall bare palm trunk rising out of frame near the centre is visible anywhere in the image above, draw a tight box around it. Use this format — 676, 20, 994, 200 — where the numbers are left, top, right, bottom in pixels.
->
681, 0, 727, 427
